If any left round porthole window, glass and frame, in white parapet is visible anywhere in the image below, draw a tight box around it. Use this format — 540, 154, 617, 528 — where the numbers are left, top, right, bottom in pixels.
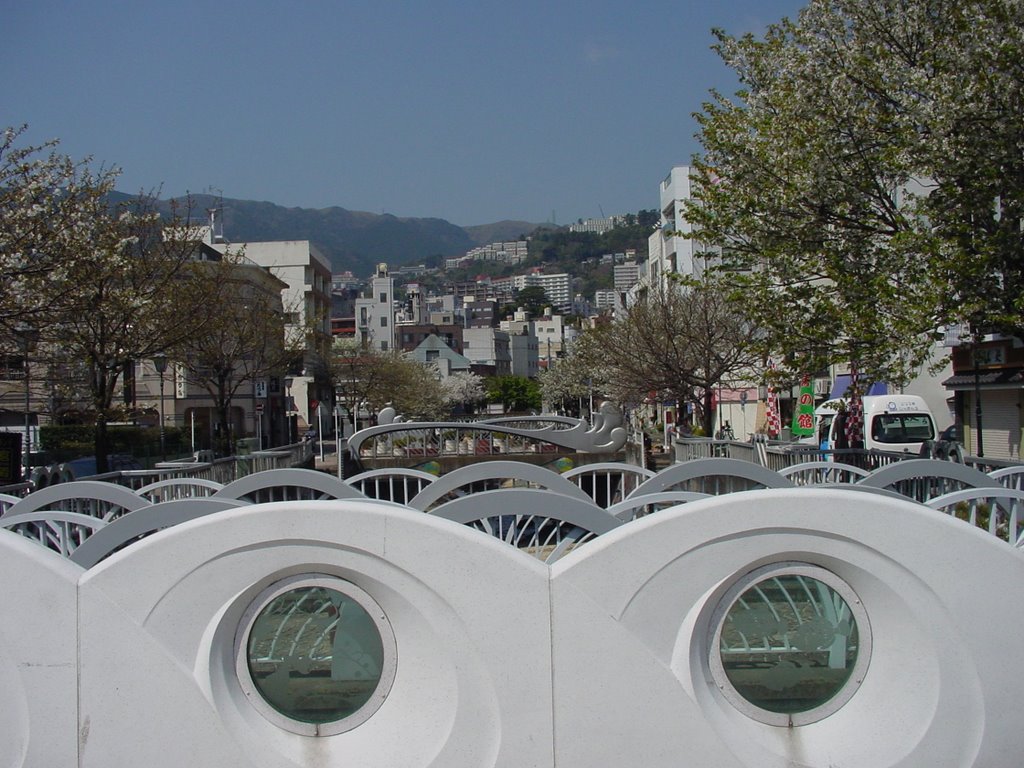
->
236, 574, 397, 735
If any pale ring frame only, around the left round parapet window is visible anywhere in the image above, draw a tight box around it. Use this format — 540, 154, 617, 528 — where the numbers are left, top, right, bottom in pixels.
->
234, 573, 398, 736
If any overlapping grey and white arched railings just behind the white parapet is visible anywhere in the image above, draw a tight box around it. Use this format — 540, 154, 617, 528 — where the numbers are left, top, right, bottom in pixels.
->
8, 458, 1024, 562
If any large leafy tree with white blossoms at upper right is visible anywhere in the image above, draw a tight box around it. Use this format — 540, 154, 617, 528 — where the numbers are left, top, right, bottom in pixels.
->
688, 0, 1024, 383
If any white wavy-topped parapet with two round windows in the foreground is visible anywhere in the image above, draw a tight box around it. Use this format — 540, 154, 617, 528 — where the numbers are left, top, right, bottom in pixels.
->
0, 487, 1024, 768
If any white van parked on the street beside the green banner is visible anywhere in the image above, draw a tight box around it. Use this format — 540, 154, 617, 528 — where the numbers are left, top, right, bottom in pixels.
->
814, 394, 937, 454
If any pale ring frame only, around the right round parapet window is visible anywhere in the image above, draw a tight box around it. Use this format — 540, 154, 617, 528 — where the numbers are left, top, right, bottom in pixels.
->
706, 561, 871, 728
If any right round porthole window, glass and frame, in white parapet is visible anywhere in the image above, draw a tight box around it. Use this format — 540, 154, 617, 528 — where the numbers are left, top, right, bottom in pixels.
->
711, 563, 870, 726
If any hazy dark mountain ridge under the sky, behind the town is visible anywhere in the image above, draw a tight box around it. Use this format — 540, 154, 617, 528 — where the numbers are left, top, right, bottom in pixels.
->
143, 195, 539, 276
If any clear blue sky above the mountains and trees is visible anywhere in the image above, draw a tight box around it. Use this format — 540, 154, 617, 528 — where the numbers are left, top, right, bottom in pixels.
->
0, 0, 802, 225
